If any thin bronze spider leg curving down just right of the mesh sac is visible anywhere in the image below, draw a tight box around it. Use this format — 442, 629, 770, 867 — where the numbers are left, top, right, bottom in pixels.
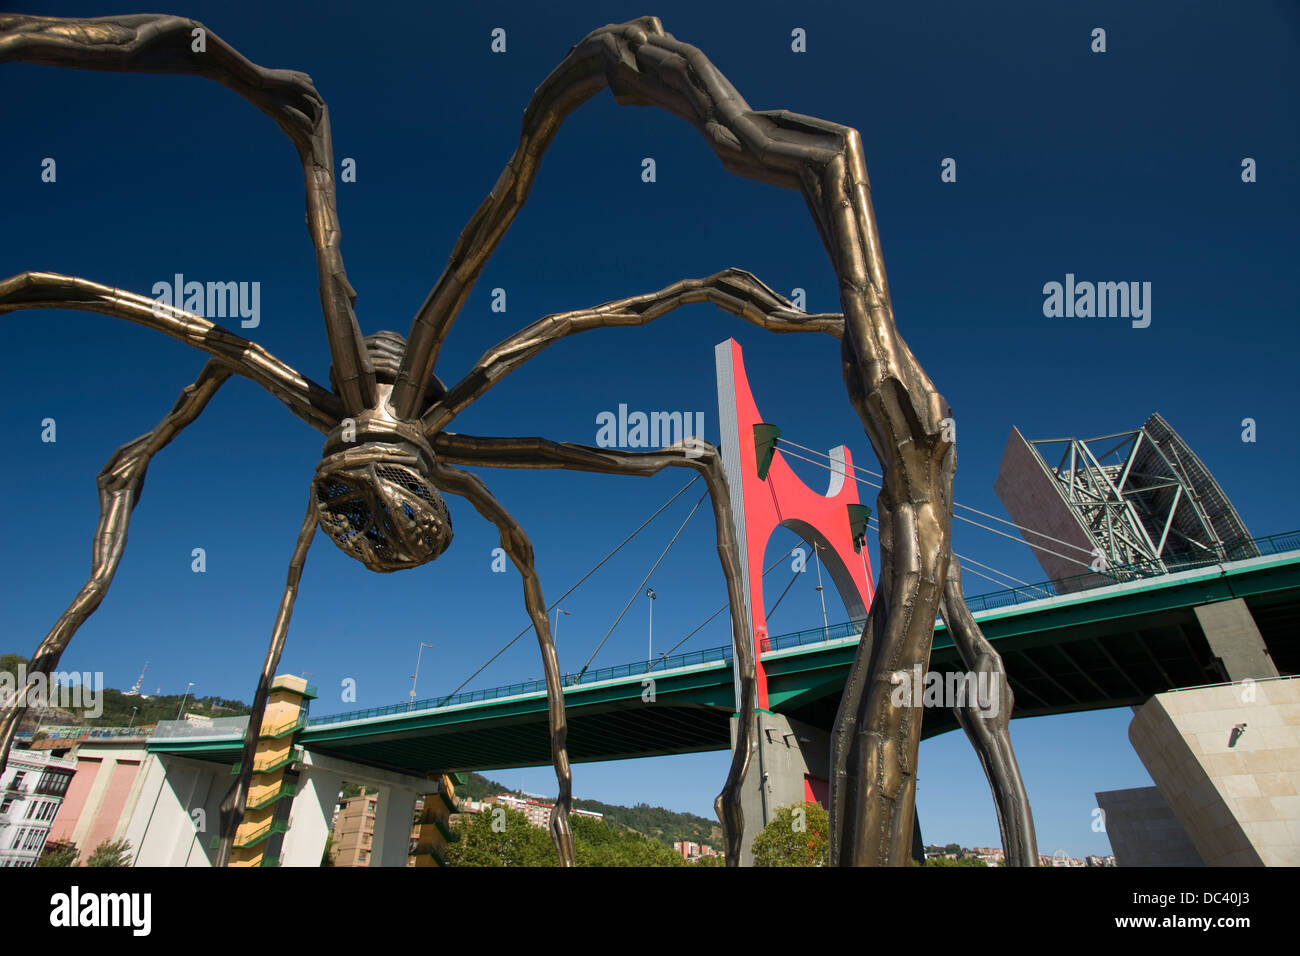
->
421, 462, 577, 866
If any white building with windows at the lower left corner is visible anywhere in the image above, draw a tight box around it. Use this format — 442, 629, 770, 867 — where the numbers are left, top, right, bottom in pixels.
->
0, 748, 77, 866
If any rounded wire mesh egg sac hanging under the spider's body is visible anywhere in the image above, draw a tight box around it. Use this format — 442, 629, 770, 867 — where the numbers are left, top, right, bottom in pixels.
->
316, 462, 451, 571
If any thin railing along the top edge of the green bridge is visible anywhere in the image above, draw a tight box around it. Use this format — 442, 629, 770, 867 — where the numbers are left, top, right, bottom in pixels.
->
307, 531, 1300, 727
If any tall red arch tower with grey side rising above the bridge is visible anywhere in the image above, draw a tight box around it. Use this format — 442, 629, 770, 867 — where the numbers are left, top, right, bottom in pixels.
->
714, 338, 875, 710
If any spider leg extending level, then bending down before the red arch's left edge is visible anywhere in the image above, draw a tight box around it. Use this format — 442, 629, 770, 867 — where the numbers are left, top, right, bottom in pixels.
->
433, 432, 758, 866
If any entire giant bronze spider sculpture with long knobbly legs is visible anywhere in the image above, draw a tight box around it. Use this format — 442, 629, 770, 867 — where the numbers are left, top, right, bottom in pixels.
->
0, 14, 1037, 865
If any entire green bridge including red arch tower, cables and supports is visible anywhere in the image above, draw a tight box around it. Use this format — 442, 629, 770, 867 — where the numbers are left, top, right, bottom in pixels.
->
133, 339, 1300, 866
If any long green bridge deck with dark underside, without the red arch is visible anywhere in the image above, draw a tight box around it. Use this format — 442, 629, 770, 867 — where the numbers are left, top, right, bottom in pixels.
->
150, 532, 1300, 777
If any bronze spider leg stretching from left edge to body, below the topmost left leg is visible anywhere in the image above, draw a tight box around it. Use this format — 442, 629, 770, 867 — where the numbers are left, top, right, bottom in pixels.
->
0, 272, 343, 433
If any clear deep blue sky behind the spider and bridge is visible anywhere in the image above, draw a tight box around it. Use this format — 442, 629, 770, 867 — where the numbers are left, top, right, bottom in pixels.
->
0, 1, 1300, 855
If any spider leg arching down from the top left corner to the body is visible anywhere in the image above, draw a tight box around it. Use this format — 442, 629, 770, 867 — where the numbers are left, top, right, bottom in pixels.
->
0, 13, 378, 414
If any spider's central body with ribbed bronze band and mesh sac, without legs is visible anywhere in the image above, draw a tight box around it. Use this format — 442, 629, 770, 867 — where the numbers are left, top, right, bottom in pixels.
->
313, 392, 451, 571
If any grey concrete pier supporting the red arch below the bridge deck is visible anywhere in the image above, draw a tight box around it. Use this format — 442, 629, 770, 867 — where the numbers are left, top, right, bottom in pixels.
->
732, 710, 831, 866
